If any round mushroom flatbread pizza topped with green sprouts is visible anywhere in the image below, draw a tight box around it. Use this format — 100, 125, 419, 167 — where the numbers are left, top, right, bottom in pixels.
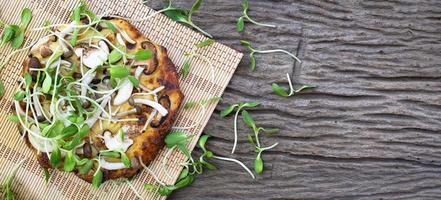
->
13, 11, 184, 185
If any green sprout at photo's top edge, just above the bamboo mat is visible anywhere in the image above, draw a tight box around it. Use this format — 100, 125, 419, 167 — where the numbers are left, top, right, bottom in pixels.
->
163, 0, 213, 38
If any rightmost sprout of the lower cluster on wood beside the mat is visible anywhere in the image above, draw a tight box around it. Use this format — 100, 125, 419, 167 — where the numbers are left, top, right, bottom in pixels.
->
242, 110, 279, 174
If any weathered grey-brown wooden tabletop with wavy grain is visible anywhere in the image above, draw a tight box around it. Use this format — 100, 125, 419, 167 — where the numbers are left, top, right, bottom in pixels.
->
148, 0, 441, 199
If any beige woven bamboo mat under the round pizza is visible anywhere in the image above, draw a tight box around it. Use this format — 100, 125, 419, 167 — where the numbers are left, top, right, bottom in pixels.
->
0, 0, 242, 199
